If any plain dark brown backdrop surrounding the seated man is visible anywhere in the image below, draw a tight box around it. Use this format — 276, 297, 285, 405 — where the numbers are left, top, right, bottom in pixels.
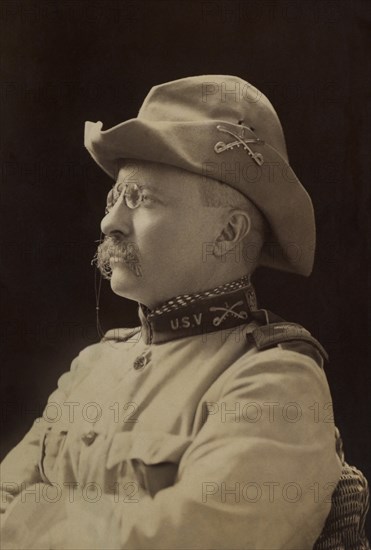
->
0, 0, 371, 544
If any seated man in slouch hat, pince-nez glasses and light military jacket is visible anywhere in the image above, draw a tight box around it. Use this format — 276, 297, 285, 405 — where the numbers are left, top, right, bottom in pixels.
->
2, 75, 367, 550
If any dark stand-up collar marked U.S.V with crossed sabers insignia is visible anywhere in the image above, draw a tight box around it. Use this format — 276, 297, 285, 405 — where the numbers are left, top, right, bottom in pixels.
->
139, 276, 257, 344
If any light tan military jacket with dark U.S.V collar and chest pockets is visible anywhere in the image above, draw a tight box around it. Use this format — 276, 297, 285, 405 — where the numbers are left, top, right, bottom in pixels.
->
2, 289, 341, 550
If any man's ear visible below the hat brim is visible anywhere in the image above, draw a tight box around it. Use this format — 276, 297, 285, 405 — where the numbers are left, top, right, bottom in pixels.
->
214, 208, 251, 256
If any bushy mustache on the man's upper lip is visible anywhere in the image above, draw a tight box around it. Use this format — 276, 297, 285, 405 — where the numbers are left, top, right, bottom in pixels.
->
91, 236, 142, 280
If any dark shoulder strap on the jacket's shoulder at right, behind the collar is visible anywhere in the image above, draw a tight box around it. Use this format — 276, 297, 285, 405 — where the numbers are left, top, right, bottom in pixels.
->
246, 316, 328, 368
